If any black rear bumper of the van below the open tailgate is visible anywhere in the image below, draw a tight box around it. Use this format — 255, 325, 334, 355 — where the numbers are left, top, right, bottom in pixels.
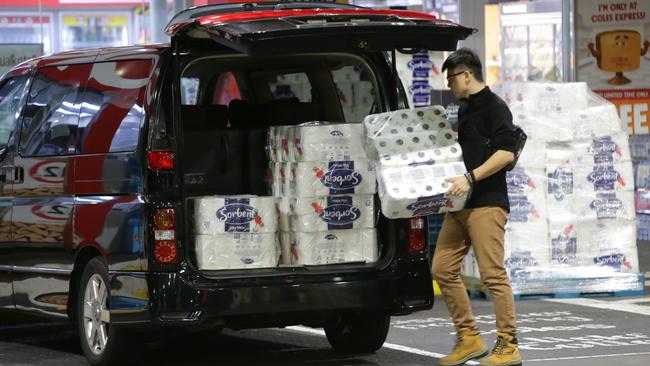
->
111, 258, 433, 328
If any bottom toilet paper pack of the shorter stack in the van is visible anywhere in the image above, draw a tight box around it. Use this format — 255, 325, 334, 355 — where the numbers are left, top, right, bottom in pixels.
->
195, 233, 280, 270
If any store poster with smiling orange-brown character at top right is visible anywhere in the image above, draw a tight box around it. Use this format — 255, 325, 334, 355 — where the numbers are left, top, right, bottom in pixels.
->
575, 0, 650, 134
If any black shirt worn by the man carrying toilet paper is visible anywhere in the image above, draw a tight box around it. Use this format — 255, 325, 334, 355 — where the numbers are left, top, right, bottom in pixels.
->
458, 86, 517, 212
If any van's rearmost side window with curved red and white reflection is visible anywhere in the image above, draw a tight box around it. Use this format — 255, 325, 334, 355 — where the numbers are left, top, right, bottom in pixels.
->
77, 60, 153, 154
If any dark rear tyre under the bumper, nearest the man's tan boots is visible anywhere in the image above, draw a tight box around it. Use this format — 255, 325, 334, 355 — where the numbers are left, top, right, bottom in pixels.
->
325, 310, 390, 353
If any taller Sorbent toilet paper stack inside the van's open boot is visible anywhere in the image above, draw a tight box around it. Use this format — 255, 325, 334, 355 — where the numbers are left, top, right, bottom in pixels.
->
267, 122, 379, 265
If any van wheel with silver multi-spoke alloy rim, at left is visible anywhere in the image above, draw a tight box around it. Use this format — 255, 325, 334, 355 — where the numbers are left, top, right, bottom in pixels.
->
77, 258, 120, 366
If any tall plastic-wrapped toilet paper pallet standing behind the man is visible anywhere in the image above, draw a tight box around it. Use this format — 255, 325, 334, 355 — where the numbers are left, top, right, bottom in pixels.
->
463, 83, 643, 294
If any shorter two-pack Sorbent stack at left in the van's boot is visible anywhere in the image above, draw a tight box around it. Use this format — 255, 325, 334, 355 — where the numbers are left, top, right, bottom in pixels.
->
188, 196, 280, 270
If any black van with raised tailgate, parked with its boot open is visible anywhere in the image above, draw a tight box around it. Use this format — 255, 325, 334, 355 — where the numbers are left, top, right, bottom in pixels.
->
0, 2, 472, 365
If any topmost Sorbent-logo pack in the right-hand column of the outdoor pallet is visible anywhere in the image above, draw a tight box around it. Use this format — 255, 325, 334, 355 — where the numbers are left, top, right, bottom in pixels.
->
572, 132, 632, 165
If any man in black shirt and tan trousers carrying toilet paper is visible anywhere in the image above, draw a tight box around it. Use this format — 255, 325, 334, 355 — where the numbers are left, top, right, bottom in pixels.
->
432, 48, 521, 366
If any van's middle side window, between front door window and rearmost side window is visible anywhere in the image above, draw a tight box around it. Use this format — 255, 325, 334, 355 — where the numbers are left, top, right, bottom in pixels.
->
20, 65, 88, 156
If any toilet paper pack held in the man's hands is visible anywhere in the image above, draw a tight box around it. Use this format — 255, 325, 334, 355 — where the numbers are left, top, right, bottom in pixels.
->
363, 106, 467, 218
